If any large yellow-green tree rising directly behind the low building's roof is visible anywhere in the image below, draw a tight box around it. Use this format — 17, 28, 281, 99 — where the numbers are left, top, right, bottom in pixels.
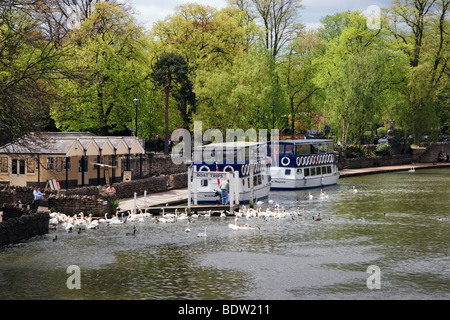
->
52, 2, 149, 135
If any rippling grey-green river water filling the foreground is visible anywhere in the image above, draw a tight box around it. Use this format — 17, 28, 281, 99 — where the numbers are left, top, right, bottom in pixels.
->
0, 169, 450, 300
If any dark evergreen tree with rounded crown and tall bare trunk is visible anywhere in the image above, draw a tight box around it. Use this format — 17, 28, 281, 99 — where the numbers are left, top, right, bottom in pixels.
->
152, 52, 195, 154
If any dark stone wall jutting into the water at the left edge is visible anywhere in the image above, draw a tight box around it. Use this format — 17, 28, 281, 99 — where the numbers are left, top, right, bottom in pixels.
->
0, 205, 50, 246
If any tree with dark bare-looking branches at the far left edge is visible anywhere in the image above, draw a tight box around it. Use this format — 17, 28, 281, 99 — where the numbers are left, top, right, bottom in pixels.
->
0, 0, 70, 143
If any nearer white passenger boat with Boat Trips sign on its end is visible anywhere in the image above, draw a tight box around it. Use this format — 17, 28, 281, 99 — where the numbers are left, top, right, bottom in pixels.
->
192, 142, 270, 204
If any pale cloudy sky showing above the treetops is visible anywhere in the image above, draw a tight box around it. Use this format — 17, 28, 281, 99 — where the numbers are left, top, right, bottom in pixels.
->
128, 0, 392, 30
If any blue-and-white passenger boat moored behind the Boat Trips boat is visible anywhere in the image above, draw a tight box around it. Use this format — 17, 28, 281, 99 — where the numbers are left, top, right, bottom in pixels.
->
269, 139, 340, 190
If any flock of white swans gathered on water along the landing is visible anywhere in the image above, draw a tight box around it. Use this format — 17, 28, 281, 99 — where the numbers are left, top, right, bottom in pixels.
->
49, 186, 366, 241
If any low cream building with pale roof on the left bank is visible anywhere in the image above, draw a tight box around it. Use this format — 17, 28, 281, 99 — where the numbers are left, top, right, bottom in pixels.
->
0, 132, 145, 189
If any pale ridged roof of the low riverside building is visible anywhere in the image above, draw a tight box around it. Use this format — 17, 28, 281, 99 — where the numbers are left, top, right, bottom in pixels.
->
0, 132, 145, 157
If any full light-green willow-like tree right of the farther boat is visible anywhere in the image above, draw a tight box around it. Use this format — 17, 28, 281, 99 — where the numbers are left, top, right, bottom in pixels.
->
314, 12, 405, 147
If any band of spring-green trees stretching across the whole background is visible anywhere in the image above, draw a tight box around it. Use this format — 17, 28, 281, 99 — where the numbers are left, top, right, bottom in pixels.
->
0, 0, 450, 150
